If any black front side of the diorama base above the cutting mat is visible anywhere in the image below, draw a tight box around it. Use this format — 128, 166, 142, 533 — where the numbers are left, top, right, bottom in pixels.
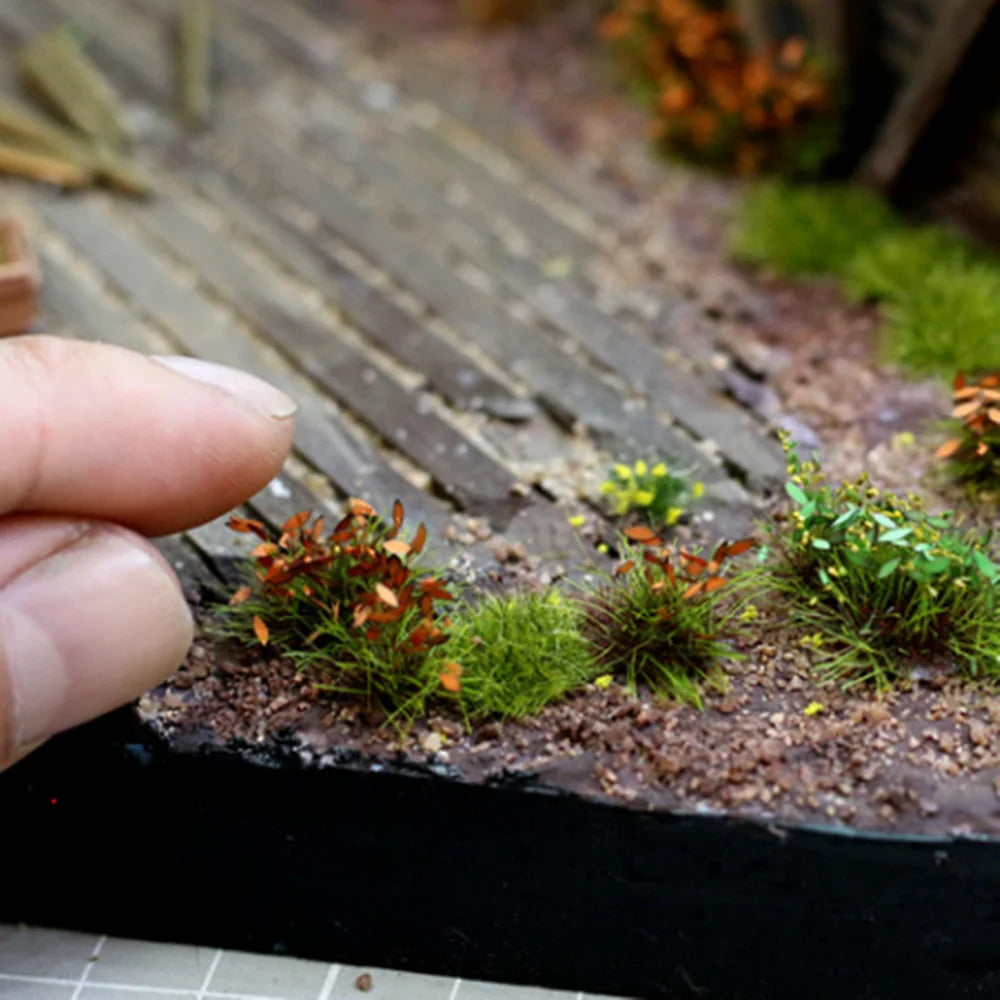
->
0, 713, 1000, 1000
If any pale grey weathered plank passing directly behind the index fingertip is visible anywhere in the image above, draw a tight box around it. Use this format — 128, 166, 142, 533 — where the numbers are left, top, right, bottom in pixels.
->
39, 193, 448, 528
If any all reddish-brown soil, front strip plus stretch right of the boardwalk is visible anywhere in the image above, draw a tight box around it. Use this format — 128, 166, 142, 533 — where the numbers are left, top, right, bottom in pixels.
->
141, 0, 1000, 836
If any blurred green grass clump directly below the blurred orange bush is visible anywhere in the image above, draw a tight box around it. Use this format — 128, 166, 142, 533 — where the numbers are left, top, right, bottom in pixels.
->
731, 182, 900, 277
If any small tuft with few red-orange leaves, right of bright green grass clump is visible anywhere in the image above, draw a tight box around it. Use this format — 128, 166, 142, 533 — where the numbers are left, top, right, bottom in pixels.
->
582, 527, 755, 706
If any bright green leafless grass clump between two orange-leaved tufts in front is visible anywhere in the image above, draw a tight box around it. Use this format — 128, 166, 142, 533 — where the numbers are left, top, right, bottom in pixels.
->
435, 590, 600, 719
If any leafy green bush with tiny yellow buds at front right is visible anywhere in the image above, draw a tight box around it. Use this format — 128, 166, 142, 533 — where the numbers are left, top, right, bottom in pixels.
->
769, 443, 1000, 687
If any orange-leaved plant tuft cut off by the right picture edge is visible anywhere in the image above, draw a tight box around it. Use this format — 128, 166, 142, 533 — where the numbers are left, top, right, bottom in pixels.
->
936, 372, 1000, 487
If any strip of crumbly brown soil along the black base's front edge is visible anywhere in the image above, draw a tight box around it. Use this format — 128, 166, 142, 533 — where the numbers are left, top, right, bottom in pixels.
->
148, 620, 1000, 836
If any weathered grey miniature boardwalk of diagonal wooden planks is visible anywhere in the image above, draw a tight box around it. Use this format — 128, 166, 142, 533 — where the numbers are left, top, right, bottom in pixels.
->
0, 0, 783, 583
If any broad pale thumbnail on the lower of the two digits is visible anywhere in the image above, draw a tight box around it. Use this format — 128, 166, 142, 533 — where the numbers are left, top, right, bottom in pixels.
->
0, 525, 193, 757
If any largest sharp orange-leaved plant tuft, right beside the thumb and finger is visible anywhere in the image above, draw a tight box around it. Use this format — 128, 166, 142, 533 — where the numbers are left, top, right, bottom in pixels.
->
215, 500, 460, 716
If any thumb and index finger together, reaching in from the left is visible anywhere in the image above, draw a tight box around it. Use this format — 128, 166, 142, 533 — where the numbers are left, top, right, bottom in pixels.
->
0, 336, 295, 769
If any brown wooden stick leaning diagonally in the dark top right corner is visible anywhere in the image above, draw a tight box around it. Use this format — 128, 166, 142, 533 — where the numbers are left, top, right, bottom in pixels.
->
856, 0, 997, 191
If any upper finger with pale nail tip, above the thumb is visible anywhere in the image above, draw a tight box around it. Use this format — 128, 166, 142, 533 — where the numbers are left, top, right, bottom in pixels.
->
0, 336, 295, 535
